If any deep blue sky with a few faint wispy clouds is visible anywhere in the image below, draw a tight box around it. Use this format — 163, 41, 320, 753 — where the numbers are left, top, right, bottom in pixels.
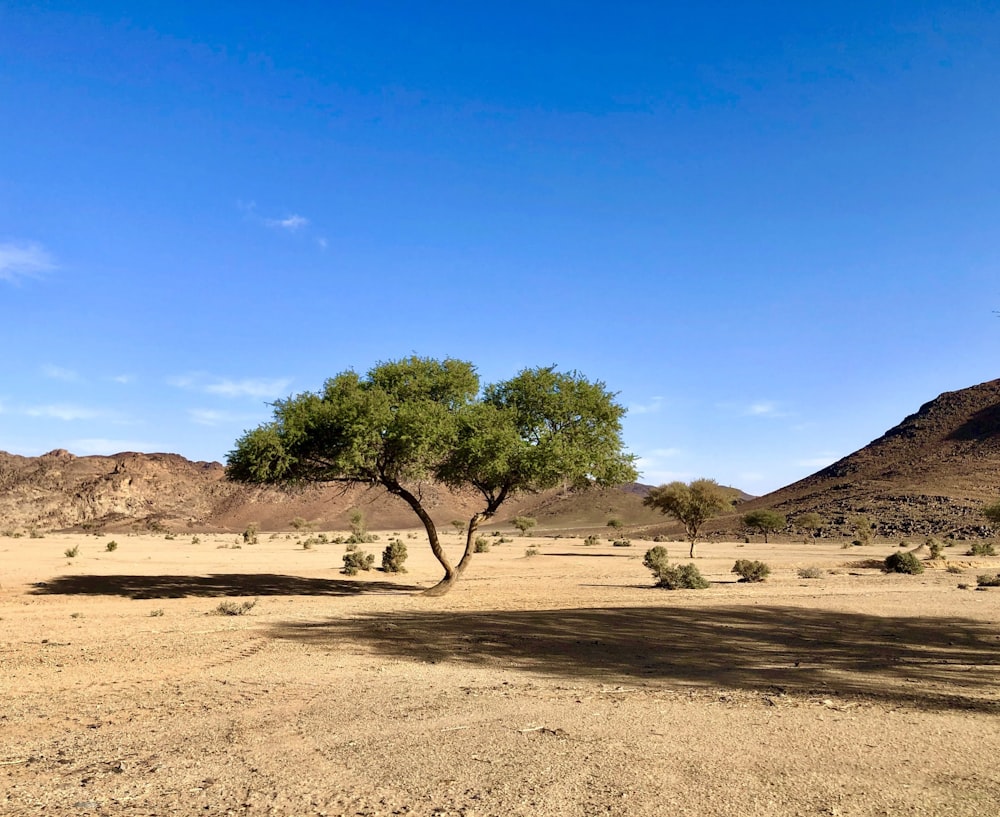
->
0, 0, 1000, 493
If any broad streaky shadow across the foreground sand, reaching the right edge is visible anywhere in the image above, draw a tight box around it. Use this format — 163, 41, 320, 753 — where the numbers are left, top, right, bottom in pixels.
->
272, 606, 1000, 713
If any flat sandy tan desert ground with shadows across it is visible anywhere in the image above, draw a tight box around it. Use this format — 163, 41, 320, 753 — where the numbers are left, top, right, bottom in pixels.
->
0, 533, 1000, 817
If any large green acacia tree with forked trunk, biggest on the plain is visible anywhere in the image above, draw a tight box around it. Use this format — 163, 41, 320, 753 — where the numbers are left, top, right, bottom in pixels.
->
226, 357, 636, 595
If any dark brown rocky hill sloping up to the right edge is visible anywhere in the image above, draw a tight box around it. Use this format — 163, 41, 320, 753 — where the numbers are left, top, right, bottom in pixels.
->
732, 380, 1000, 537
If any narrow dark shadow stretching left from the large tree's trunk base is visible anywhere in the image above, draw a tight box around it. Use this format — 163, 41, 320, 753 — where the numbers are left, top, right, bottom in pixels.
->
31, 573, 424, 599
